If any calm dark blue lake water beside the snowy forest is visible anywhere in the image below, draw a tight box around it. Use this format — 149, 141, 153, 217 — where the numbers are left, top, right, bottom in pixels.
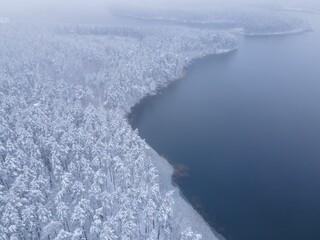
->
132, 15, 320, 240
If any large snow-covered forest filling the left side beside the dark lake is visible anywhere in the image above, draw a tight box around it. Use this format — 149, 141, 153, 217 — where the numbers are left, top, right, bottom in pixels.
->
0, 4, 310, 240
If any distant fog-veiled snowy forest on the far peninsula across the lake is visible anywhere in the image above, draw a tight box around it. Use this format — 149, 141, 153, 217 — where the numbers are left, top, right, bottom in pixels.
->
114, 6, 310, 36
